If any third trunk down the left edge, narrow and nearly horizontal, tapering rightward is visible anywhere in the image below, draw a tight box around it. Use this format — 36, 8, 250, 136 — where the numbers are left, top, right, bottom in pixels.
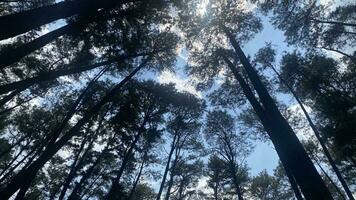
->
0, 52, 149, 95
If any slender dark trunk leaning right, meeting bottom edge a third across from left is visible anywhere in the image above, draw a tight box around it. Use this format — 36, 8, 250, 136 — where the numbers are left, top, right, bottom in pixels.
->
105, 118, 146, 200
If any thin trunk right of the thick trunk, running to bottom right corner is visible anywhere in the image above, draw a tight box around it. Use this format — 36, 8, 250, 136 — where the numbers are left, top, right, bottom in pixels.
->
271, 66, 355, 200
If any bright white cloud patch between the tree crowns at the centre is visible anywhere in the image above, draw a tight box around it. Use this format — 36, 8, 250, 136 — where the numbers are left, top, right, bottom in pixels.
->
157, 71, 202, 98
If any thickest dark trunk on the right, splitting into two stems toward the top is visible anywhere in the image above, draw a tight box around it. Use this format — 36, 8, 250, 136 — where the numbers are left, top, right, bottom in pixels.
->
224, 41, 332, 200
